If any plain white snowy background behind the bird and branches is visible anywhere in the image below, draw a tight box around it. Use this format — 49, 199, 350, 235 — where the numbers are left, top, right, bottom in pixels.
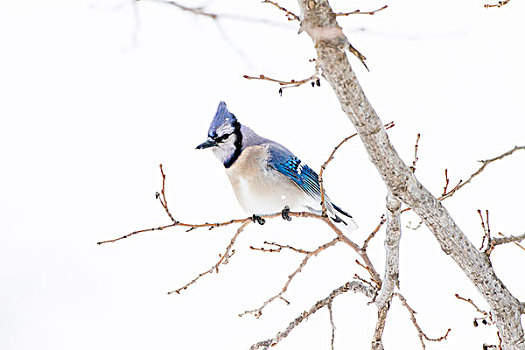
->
0, 0, 525, 350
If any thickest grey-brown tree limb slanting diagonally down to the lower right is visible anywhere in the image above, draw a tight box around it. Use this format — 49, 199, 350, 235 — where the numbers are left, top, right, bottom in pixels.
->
299, 0, 525, 350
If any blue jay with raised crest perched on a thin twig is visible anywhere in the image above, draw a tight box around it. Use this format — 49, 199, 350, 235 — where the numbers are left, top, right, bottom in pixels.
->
197, 101, 357, 230
